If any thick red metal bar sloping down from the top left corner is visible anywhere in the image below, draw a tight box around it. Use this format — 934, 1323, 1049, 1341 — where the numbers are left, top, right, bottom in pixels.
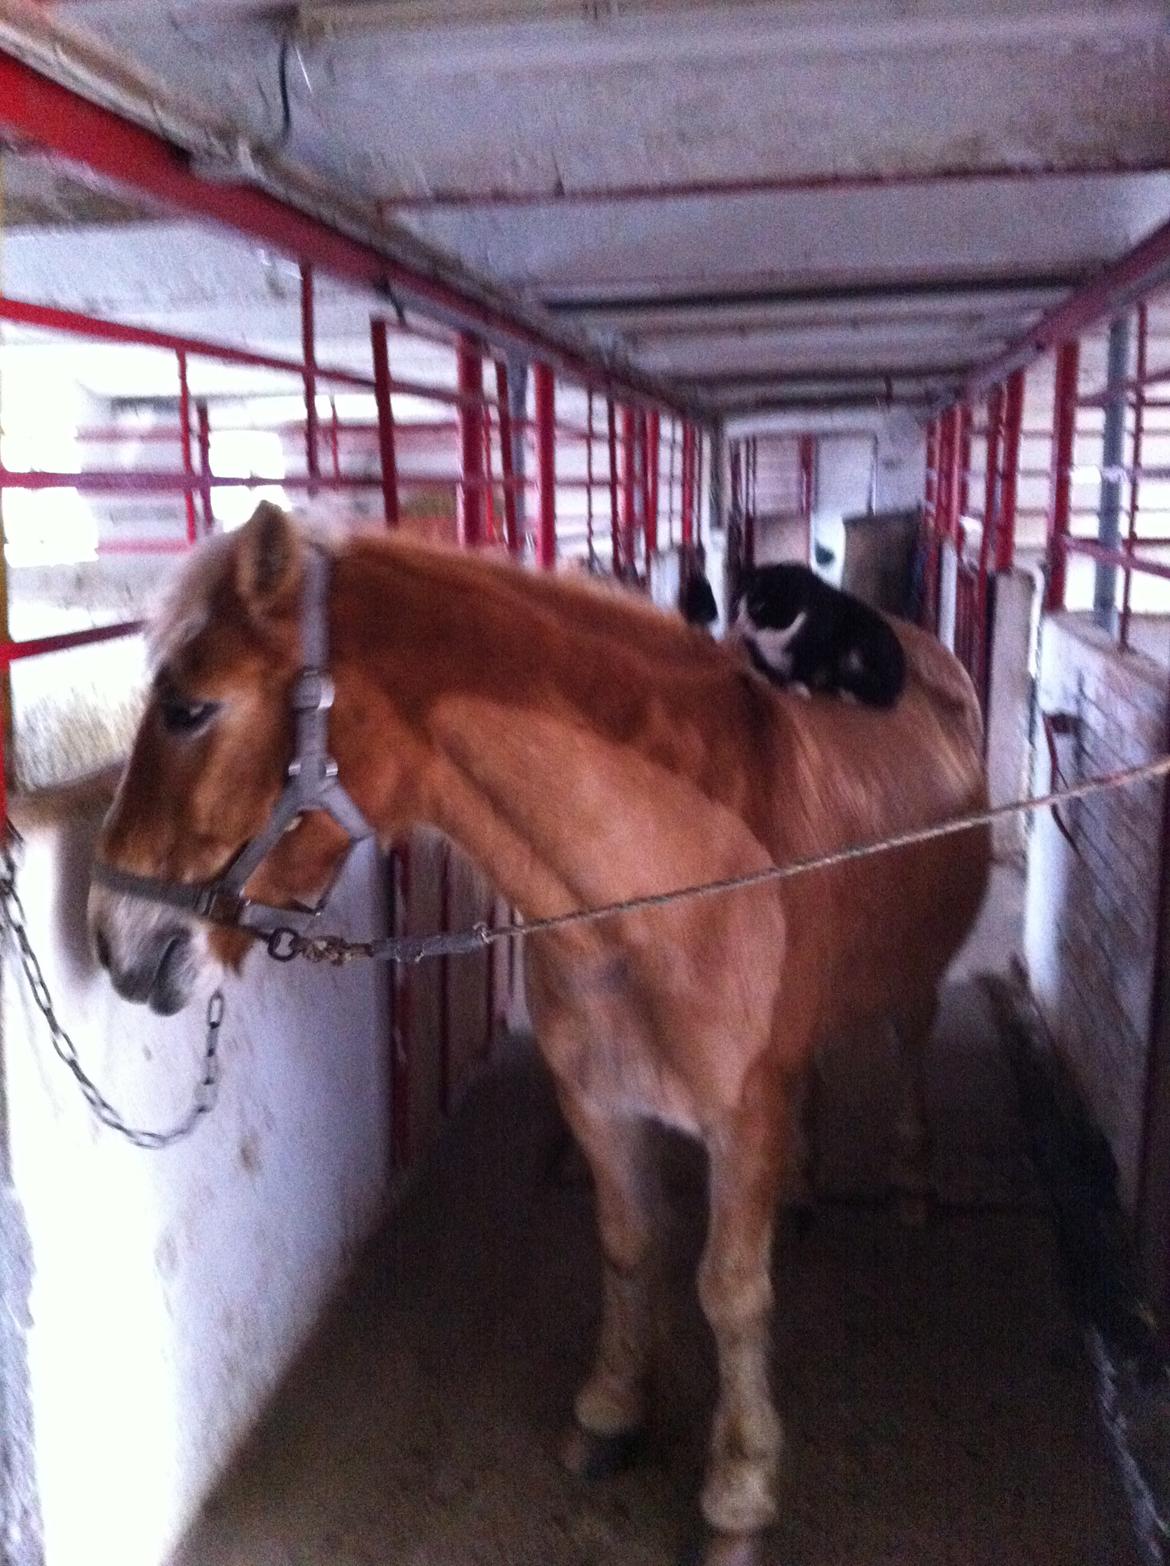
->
0, 53, 686, 419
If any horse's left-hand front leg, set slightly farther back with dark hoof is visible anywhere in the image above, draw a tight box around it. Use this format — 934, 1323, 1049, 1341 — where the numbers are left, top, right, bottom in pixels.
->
558, 1082, 659, 1477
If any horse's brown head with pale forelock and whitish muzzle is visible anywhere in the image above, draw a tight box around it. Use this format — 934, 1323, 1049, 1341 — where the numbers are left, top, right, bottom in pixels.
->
89, 504, 363, 1013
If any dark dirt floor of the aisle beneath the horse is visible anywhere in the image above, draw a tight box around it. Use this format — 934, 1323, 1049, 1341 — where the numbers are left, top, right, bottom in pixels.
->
180, 876, 1137, 1566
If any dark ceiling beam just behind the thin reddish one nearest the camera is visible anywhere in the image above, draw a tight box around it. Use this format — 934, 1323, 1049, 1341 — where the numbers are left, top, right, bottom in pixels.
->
542, 272, 1084, 316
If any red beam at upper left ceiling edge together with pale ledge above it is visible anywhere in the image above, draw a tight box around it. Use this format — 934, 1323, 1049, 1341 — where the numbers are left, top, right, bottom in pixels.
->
0, 26, 702, 413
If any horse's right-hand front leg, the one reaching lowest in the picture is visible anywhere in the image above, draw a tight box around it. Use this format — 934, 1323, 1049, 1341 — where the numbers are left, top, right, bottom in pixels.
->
699, 1082, 793, 1561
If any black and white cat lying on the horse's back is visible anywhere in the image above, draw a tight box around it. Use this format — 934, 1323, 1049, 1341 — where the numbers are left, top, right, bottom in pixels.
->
733, 565, 905, 706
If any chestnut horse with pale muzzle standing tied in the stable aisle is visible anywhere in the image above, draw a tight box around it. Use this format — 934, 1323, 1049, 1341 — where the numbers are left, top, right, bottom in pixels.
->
91, 506, 988, 1563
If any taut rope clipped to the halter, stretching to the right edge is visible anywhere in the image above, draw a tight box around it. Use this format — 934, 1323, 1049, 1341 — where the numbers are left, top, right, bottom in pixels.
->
261, 755, 1170, 968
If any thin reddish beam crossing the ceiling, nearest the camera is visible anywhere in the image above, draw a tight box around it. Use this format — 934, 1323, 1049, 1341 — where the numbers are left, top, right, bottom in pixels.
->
377, 158, 1170, 216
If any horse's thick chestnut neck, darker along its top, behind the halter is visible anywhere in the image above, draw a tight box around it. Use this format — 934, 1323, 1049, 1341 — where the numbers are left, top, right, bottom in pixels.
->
338, 544, 761, 916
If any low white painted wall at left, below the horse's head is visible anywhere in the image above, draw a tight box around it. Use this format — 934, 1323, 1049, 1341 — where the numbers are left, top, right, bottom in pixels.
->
2, 797, 390, 1566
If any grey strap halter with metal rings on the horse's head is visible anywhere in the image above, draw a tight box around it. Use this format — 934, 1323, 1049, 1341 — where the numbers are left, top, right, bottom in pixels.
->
92, 543, 374, 933
